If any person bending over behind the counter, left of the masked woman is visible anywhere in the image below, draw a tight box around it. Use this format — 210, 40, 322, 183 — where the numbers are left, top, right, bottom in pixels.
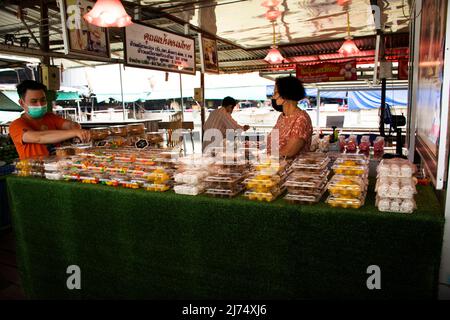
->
203, 97, 250, 151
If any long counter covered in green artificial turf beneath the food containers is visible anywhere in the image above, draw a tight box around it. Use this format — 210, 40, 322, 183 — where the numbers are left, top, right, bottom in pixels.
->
7, 176, 444, 299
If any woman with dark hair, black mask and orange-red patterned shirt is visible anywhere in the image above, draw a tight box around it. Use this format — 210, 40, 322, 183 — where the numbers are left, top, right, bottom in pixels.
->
267, 76, 313, 158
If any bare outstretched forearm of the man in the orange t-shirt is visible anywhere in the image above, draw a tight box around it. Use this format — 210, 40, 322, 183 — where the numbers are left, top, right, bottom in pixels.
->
22, 129, 90, 144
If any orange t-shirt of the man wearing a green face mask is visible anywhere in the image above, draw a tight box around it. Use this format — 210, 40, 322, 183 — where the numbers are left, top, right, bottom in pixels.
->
9, 112, 66, 160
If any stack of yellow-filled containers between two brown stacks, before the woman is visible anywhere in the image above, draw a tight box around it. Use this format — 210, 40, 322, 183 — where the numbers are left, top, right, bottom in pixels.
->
244, 159, 289, 202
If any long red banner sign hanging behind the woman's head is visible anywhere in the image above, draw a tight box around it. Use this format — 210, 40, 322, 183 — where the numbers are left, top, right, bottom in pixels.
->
296, 60, 358, 83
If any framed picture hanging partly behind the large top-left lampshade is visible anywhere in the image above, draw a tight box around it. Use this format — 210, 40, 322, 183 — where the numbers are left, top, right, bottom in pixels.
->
59, 0, 110, 58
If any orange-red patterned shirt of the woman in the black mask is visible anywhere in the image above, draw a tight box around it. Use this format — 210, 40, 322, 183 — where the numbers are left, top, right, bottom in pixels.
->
267, 109, 313, 153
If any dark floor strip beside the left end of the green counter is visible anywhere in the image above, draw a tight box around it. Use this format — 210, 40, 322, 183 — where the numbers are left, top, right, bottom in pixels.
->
0, 229, 26, 300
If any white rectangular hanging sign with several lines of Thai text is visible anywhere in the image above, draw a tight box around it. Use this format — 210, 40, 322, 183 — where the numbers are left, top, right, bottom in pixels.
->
123, 22, 195, 75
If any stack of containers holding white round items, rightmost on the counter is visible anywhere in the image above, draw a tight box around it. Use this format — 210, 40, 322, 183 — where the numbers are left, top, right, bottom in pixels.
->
375, 158, 417, 213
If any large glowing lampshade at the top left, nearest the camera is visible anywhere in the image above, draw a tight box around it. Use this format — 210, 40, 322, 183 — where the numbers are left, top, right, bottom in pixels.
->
83, 0, 133, 28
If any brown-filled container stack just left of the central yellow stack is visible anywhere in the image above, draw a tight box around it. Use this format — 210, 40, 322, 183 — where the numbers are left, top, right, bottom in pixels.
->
205, 154, 249, 198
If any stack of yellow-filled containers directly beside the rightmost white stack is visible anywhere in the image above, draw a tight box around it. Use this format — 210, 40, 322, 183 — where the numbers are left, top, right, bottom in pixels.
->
326, 154, 369, 209
